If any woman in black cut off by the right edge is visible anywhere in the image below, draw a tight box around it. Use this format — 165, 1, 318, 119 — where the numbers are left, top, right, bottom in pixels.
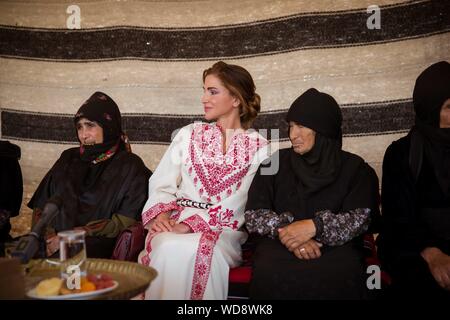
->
377, 61, 450, 299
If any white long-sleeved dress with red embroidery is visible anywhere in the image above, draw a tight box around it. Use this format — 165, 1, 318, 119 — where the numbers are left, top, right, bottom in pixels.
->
139, 123, 268, 299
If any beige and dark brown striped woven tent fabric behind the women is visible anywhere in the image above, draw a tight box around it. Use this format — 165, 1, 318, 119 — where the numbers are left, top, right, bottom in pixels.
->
0, 0, 450, 235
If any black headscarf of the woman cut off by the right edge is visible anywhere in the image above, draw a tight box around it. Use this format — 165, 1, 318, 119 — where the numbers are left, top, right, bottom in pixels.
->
409, 61, 450, 196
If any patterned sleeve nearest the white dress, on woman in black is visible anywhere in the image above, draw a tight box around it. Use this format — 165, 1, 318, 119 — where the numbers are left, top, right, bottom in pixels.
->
245, 209, 294, 239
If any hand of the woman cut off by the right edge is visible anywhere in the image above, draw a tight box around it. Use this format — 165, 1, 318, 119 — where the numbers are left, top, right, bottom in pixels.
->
421, 247, 450, 290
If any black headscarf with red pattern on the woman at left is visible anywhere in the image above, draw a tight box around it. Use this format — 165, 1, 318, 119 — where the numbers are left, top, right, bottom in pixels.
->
74, 92, 124, 161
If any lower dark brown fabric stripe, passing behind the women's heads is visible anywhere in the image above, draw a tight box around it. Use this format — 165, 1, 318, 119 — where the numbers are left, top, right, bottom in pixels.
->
1, 100, 414, 144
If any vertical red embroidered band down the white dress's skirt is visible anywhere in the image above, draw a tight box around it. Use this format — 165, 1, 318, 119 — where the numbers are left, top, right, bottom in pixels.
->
191, 231, 220, 300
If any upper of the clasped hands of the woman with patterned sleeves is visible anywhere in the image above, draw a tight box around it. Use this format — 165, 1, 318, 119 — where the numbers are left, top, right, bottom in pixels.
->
278, 219, 316, 252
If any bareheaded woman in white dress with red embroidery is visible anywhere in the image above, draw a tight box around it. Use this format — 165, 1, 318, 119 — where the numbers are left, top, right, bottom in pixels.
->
139, 62, 267, 299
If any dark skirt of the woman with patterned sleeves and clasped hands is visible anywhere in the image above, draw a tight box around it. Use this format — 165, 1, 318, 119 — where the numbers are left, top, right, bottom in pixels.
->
250, 238, 369, 300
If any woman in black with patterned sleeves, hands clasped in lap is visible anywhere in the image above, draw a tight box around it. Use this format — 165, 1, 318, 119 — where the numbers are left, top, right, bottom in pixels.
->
245, 89, 379, 299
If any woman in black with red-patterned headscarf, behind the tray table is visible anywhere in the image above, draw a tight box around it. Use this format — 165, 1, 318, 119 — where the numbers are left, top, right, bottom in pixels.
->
28, 92, 151, 258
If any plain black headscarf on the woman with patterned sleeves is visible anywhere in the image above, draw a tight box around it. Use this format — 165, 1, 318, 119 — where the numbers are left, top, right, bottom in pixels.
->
286, 88, 342, 195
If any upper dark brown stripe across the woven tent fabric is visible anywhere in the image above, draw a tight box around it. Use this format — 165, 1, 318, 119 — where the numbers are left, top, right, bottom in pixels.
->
0, 1, 450, 61
